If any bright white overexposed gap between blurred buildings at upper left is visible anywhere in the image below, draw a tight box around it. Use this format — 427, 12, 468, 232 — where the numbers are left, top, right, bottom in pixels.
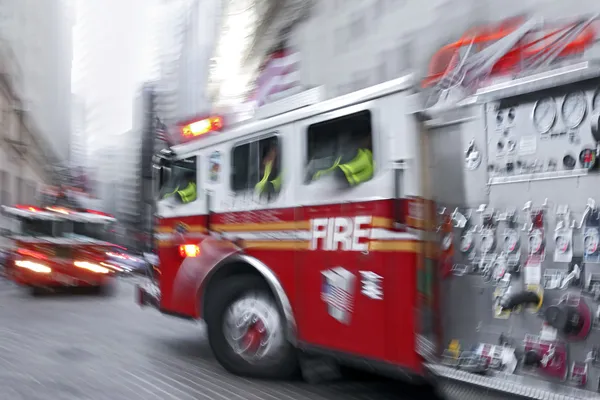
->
73, 0, 146, 162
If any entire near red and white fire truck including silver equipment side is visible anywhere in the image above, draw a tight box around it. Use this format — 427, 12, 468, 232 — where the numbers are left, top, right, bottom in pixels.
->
139, 15, 600, 400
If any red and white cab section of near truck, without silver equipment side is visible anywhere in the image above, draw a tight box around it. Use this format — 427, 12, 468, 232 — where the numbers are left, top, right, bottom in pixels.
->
138, 76, 439, 384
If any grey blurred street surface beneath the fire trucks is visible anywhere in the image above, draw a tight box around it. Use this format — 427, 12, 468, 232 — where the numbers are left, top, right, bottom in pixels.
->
0, 277, 506, 400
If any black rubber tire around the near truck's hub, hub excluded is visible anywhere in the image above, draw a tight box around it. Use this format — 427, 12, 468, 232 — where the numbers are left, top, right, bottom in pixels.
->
204, 275, 299, 379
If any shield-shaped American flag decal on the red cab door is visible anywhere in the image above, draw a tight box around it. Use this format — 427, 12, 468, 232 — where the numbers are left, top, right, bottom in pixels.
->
321, 267, 356, 324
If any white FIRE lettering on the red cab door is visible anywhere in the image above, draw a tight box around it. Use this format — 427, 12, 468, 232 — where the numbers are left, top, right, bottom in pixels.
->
310, 216, 371, 251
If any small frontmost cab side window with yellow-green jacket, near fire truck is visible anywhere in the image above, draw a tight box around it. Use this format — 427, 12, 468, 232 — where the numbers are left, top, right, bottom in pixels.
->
160, 156, 199, 204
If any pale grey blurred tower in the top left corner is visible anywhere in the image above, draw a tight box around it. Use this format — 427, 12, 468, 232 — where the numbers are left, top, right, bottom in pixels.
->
0, 0, 73, 162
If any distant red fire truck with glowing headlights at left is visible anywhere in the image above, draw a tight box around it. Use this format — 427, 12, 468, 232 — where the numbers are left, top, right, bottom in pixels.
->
2, 205, 118, 294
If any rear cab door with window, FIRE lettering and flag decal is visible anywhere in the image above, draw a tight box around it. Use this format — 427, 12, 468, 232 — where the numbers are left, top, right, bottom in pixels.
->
296, 102, 385, 359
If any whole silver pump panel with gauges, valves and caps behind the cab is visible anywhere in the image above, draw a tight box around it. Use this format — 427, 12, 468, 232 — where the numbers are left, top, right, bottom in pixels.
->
433, 81, 600, 398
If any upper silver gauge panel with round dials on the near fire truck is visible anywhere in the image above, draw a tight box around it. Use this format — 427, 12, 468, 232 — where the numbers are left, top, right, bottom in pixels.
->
486, 83, 600, 177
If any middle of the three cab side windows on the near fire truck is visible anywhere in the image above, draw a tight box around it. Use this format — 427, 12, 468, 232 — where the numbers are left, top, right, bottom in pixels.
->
231, 136, 281, 199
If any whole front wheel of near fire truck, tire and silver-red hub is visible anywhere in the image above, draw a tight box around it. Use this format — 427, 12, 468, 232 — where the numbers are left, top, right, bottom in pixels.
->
205, 275, 299, 379
